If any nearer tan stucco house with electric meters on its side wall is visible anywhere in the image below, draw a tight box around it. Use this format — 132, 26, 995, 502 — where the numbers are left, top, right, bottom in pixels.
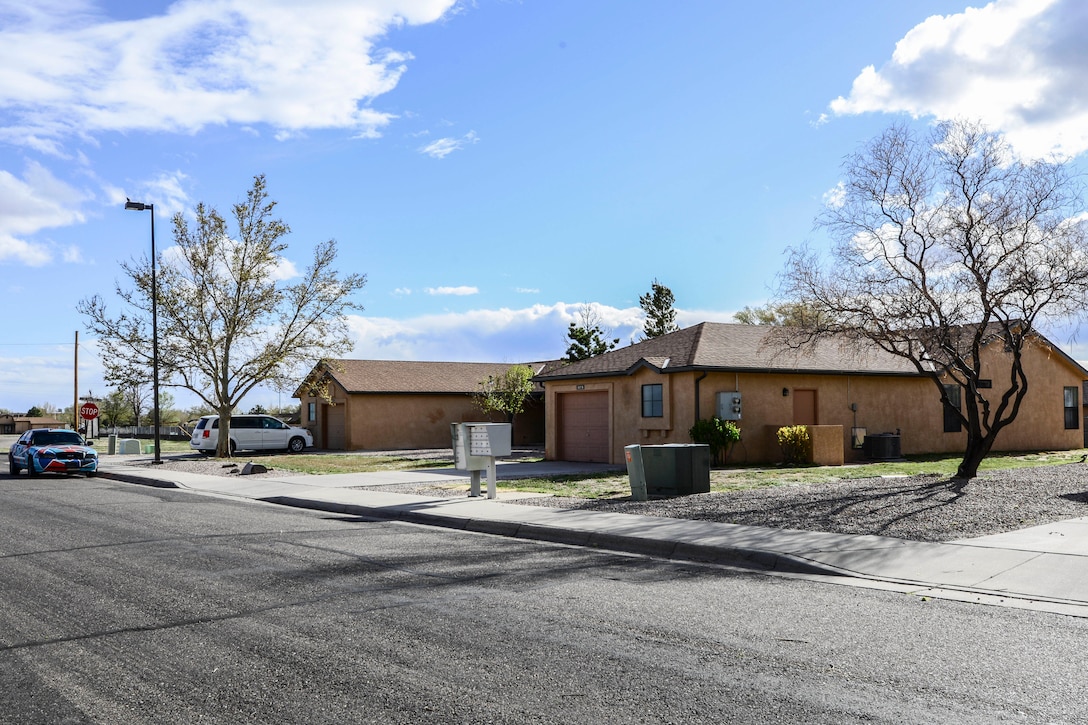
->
536, 322, 1088, 464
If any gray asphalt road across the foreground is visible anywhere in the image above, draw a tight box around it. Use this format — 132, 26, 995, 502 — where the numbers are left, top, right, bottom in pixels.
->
0, 475, 1088, 724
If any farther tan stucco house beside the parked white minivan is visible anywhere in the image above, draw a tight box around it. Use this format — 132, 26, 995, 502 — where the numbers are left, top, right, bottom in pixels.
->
295, 359, 546, 451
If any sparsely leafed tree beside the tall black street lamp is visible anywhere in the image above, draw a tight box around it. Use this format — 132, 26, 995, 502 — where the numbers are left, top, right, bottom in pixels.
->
79, 176, 367, 456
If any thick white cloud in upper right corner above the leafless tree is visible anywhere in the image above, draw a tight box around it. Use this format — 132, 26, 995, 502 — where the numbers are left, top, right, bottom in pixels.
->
830, 0, 1088, 158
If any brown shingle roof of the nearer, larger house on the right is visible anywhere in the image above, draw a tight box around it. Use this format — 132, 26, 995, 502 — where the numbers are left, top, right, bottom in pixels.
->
537, 322, 918, 380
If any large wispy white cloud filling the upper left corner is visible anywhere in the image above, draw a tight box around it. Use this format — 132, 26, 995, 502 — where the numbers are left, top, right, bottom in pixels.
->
0, 0, 456, 148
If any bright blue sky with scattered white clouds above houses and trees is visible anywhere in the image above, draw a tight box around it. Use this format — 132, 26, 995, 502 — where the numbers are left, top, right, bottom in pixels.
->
0, 0, 1088, 411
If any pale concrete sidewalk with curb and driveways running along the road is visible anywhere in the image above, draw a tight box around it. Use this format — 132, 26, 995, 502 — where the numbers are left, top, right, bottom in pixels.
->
100, 456, 1088, 616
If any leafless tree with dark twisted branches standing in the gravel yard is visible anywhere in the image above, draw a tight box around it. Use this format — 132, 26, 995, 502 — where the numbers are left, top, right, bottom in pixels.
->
780, 121, 1088, 479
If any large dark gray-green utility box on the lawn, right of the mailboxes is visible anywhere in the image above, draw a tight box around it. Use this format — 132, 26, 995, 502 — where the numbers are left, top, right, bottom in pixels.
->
625, 443, 710, 499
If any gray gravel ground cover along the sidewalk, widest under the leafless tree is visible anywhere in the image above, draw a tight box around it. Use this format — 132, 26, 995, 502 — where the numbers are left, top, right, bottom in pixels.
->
121, 457, 1088, 541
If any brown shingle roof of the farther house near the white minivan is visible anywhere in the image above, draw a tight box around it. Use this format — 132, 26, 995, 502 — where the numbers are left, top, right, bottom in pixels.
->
313, 360, 544, 394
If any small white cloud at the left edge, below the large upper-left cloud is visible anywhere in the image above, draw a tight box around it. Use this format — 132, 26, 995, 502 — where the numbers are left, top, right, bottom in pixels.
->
0, 162, 89, 267
